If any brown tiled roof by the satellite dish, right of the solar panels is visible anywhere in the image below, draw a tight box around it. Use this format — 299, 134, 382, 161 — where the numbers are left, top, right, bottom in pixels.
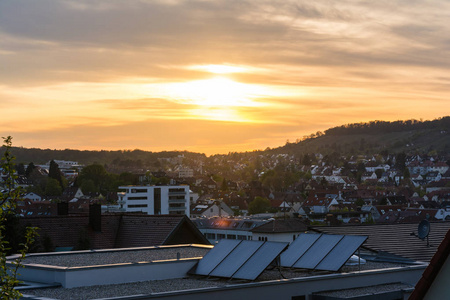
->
312, 222, 450, 261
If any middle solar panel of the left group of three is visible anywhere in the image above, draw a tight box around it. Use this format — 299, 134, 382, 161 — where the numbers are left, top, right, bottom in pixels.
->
209, 241, 264, 277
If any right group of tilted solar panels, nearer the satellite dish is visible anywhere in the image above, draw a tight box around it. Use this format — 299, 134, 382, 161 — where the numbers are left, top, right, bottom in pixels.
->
280, 233, 367, 271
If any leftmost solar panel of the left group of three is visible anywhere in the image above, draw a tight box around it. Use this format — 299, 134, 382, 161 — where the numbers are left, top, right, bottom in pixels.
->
194, 239, 241, 275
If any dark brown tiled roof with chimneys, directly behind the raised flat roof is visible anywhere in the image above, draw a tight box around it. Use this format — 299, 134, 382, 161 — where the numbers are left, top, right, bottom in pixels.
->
20, 214, 209, 249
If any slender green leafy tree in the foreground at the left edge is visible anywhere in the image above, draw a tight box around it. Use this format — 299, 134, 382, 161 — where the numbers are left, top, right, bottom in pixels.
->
0, 136, 36, 299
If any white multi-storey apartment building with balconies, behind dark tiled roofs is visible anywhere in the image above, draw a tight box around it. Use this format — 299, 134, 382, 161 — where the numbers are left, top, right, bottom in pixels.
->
117, 185, 190, 217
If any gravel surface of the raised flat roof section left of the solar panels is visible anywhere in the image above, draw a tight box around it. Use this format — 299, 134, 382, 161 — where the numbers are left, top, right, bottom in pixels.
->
24, 247, 210, 267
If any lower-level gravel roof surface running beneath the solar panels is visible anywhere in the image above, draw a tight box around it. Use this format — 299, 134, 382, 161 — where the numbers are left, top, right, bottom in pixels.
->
21, 260, 410, 300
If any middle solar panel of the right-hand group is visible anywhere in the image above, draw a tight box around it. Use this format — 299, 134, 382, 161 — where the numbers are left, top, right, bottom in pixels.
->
293, 234, 344, 269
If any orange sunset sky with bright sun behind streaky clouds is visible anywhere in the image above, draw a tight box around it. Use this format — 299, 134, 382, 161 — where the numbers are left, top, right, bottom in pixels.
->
0, 0, 450, 155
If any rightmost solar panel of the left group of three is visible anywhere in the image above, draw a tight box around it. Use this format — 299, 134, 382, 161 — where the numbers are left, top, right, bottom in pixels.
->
233, 242, 289, 280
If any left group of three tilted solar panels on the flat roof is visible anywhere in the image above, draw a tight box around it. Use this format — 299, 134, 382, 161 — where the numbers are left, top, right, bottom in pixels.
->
193, 239, 288, 280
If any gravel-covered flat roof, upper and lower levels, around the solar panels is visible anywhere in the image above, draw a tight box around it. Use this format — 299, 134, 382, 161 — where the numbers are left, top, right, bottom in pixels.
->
17, 245, 418, 299
